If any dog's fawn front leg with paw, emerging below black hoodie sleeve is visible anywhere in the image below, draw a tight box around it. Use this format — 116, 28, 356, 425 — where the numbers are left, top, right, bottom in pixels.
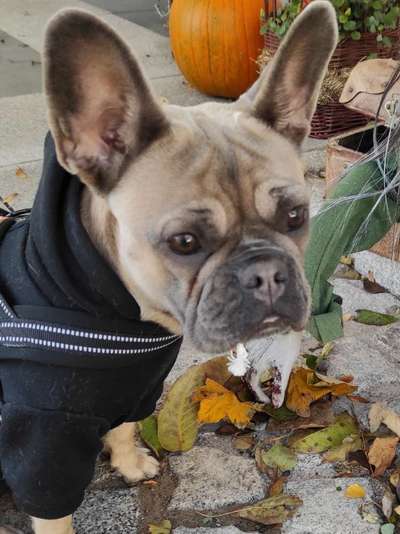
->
104, 423, 159, 484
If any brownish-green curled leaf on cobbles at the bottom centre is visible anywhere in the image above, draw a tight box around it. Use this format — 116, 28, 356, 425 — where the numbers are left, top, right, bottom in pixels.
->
234, 495, 303, 525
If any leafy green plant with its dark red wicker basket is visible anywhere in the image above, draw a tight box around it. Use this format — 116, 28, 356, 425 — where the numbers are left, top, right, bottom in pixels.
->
259, 0, 400, 139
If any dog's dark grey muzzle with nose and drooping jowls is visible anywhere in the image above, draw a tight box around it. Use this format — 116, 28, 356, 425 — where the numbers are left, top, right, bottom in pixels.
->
186, 242, 308, 351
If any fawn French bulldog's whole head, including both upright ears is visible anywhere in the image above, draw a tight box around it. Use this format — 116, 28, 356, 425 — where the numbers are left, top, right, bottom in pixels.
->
45, 1, 337, 351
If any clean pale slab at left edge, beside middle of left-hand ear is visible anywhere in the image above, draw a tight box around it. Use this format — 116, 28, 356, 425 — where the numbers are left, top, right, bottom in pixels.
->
0, 94, 48, 167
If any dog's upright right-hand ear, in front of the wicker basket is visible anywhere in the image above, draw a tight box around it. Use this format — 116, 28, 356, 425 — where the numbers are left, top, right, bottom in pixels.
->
244, 0, 338, 145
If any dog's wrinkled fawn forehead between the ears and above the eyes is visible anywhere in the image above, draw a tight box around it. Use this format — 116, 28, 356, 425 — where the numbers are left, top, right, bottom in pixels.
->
111, 104, 308, 238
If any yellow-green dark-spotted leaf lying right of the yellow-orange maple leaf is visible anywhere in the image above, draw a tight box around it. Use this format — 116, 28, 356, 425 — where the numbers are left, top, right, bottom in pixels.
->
293, 414, 358, 453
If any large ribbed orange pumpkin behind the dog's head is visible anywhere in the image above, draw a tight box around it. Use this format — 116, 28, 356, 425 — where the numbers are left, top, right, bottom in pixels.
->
169, 0, 266, 98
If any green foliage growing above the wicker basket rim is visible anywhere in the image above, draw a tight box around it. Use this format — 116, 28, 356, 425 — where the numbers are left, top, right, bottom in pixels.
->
261, 0, 400, 43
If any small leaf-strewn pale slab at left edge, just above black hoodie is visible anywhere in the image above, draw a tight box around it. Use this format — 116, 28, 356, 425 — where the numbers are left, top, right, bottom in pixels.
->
0, 161, 42, 209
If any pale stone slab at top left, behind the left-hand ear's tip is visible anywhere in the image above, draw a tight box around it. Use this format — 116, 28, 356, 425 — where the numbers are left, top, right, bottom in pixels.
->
0, 0, 178, 78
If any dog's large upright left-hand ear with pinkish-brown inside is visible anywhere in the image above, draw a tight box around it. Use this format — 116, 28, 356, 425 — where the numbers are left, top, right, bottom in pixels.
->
44, 9, 168, 193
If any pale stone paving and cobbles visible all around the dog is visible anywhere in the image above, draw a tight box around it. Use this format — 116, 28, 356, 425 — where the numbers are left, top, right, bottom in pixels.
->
0, 0, 400, 534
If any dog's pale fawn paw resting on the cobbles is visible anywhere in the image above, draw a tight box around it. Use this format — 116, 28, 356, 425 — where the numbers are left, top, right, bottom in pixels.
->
111, 447, 160, 484
